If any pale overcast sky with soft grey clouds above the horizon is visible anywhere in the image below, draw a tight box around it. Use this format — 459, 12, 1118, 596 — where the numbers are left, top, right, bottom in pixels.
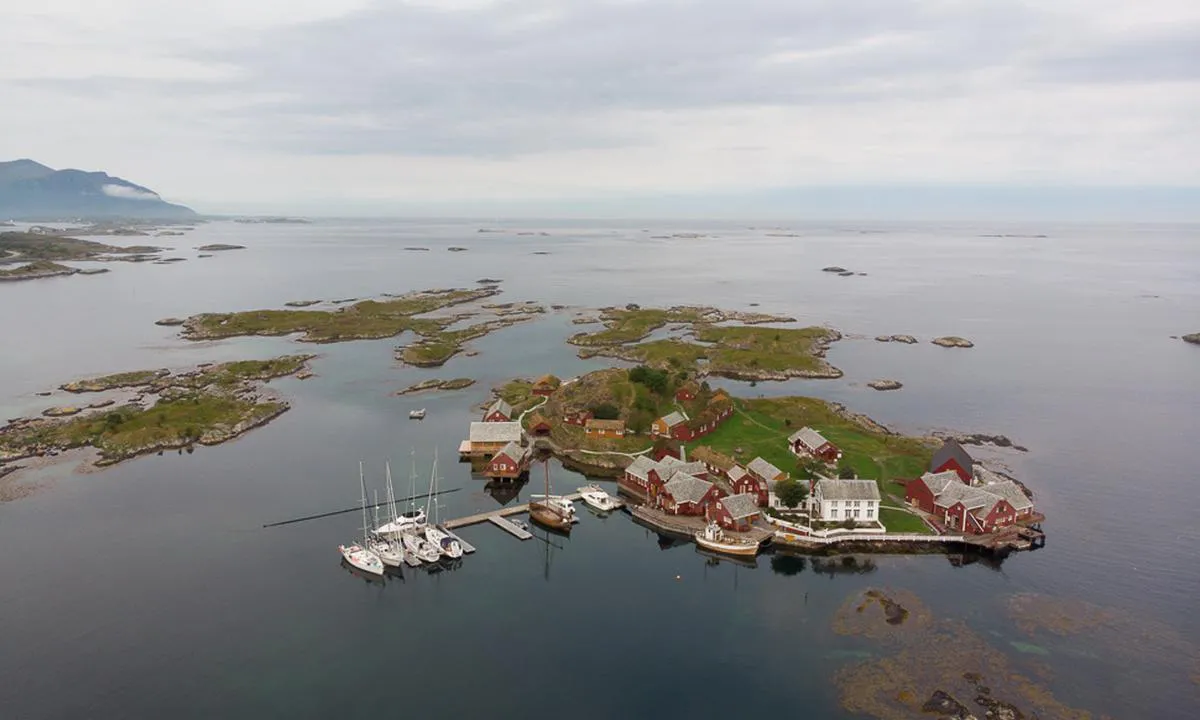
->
0, 0, 1200, 220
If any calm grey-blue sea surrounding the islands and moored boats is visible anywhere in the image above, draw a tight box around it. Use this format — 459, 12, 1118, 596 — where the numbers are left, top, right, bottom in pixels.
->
0, 220, 1200, 720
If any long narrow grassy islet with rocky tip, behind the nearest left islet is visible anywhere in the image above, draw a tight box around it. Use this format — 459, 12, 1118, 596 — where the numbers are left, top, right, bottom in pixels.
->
184, 289, 496, 342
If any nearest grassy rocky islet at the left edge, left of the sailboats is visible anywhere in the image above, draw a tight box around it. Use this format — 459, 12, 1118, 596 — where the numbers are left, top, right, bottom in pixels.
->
0, 355, 313, 474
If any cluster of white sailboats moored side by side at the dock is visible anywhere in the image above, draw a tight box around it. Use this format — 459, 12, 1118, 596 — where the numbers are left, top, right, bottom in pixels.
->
337, 457, 463, 575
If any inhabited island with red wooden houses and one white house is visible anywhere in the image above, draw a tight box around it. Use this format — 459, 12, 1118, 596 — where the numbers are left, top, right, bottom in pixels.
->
460, 365, 1044, 557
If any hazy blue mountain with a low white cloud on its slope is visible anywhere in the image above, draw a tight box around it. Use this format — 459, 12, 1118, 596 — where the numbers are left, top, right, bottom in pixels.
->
0, 160, 196, 220
